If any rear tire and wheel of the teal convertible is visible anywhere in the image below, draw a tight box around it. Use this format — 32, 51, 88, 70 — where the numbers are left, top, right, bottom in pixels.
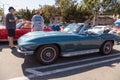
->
100, 41, 113, 55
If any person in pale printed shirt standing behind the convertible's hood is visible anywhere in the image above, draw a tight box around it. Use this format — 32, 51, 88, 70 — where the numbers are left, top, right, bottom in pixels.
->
32, 10, 44, 31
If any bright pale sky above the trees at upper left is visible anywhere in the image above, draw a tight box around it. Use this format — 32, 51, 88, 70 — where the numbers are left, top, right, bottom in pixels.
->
0, 0, 55, 14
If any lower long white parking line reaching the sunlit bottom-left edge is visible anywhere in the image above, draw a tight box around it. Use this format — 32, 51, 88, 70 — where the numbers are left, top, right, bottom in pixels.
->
9, 57, 120, 80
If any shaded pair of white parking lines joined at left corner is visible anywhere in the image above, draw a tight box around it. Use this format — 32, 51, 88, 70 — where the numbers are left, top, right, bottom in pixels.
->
26, 54, 120, 76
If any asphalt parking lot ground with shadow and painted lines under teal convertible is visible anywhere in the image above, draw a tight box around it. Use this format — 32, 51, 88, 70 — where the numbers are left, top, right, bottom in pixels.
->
0, 42, 120, 80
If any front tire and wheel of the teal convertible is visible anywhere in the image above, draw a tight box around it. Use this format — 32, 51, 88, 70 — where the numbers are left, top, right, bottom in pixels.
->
36, 45, 59, 64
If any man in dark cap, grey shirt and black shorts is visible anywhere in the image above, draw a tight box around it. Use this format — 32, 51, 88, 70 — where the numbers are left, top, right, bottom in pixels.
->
5, 7, 16, 49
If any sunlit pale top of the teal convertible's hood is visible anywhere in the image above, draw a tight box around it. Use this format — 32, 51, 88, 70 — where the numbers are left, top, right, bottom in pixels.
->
20, 31, 75, 40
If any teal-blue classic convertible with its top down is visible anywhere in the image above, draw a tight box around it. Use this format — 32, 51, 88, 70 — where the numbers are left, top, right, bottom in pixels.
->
17, 23, 120, 64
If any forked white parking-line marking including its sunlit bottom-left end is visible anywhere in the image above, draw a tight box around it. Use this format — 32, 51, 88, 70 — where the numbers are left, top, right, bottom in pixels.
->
9, 53, 120, 80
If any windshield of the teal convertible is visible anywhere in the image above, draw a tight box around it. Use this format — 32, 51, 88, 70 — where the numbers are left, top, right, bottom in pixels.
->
63, 23, 83, 33
